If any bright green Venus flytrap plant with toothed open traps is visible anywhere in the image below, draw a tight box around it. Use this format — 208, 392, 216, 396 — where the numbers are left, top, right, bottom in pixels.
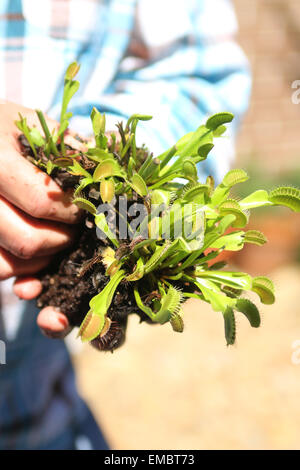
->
16, 63, 300, 344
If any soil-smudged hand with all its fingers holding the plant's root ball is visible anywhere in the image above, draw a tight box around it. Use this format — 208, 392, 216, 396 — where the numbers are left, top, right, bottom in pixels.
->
0, 101, 79, 336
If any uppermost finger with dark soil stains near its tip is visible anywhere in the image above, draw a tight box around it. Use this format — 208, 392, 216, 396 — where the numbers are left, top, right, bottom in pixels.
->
0, 145, 80, 223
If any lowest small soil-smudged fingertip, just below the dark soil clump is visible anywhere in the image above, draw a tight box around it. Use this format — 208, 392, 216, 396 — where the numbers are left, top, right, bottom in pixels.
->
37, 307, 72, 339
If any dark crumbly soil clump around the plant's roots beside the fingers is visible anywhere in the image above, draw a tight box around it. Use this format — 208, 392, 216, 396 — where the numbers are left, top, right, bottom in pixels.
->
38, 227, 139, 326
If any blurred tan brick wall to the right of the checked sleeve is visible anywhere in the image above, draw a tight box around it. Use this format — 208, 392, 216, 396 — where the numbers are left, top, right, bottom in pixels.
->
234, 0, 300, 174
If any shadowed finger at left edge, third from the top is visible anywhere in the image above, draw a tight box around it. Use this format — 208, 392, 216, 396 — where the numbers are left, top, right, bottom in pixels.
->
0, 248, 51, 281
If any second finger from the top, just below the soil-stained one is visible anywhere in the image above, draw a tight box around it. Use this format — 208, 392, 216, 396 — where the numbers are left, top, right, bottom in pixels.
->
0, 197, 74, 259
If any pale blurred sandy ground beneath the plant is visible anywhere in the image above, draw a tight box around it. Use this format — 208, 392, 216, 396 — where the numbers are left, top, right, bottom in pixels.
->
74, 267, 300, 449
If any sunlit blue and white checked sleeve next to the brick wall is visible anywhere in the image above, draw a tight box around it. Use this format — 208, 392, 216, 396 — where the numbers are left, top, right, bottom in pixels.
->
69, 0, 251, 180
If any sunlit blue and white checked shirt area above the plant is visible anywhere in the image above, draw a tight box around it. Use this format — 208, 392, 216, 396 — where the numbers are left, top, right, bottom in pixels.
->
0, 0, 251, 180
